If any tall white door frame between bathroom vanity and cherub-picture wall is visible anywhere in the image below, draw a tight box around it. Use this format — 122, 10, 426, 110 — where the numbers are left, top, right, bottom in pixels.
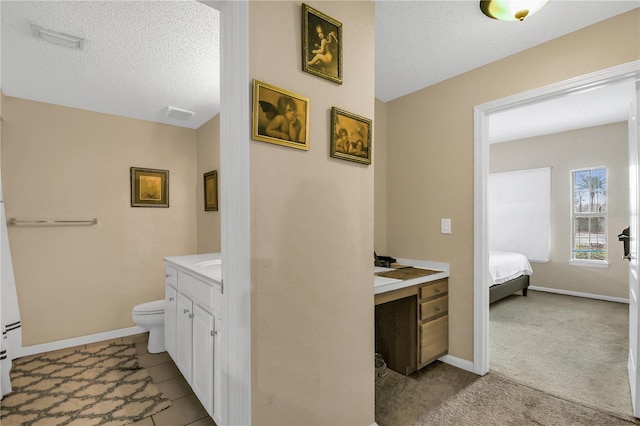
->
199, 0, 251, 426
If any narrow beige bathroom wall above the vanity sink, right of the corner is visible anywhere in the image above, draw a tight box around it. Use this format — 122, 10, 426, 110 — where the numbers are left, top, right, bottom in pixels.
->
196, 115, 221, 253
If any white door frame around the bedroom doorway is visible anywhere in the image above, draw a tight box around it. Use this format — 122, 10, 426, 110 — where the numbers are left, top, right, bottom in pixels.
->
473, 61, 640, 375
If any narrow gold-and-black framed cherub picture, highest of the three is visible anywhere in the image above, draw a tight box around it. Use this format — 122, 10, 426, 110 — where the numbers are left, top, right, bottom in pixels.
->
302, 3, 342, 84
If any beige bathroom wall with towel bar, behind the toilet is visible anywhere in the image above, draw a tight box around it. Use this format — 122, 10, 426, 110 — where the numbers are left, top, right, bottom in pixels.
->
1, 97, 202, 346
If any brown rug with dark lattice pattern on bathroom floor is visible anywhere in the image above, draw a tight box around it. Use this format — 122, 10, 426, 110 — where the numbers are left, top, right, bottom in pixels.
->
0, 343, 171, 426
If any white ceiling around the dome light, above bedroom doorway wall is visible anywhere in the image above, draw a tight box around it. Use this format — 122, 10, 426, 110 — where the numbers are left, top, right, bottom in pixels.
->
376, 0, 640, 102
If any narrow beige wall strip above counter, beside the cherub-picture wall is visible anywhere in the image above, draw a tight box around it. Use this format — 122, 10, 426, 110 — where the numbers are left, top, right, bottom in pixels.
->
373, 99, 387, 256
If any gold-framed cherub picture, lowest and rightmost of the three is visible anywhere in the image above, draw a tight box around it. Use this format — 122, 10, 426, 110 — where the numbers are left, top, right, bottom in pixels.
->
330, 107, 372, 165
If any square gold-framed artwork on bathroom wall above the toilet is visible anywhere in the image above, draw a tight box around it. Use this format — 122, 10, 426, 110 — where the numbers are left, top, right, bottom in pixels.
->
131, 167, 169, 207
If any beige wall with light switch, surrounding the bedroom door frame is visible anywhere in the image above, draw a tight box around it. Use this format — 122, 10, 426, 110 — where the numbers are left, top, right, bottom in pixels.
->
387, 9, 640, 360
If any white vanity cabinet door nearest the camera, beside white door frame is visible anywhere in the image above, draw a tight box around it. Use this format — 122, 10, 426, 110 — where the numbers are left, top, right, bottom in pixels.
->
192, 304, 214, 416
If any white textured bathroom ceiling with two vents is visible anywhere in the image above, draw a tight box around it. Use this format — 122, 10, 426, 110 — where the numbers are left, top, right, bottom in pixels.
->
1, 0, 220, 128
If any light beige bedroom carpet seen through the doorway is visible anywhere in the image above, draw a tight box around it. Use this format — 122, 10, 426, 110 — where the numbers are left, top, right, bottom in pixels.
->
489, 291, 632, 416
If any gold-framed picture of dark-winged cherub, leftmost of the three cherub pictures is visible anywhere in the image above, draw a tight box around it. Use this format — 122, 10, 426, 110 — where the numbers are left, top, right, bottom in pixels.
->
252, 80, 309, 150
